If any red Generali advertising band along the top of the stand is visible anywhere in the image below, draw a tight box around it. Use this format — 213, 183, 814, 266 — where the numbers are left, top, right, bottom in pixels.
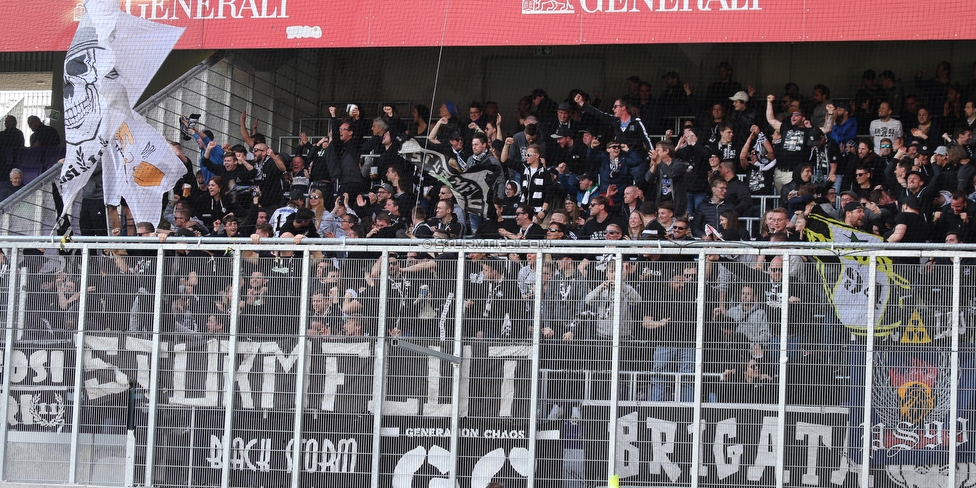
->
0, 0, 976, 52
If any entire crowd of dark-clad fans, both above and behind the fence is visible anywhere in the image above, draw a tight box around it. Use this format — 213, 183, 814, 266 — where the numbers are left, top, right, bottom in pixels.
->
7, 62, 976, 408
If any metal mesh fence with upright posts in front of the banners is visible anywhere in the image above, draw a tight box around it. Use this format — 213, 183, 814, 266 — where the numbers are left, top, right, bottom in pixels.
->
2, 241, 974, 487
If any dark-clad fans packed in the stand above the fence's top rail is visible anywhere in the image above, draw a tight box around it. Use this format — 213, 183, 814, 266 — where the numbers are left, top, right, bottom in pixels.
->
112, 62, 976, 252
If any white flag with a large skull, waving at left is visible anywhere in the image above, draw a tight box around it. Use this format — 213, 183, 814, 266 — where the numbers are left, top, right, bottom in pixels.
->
60, 0, 186, 227
